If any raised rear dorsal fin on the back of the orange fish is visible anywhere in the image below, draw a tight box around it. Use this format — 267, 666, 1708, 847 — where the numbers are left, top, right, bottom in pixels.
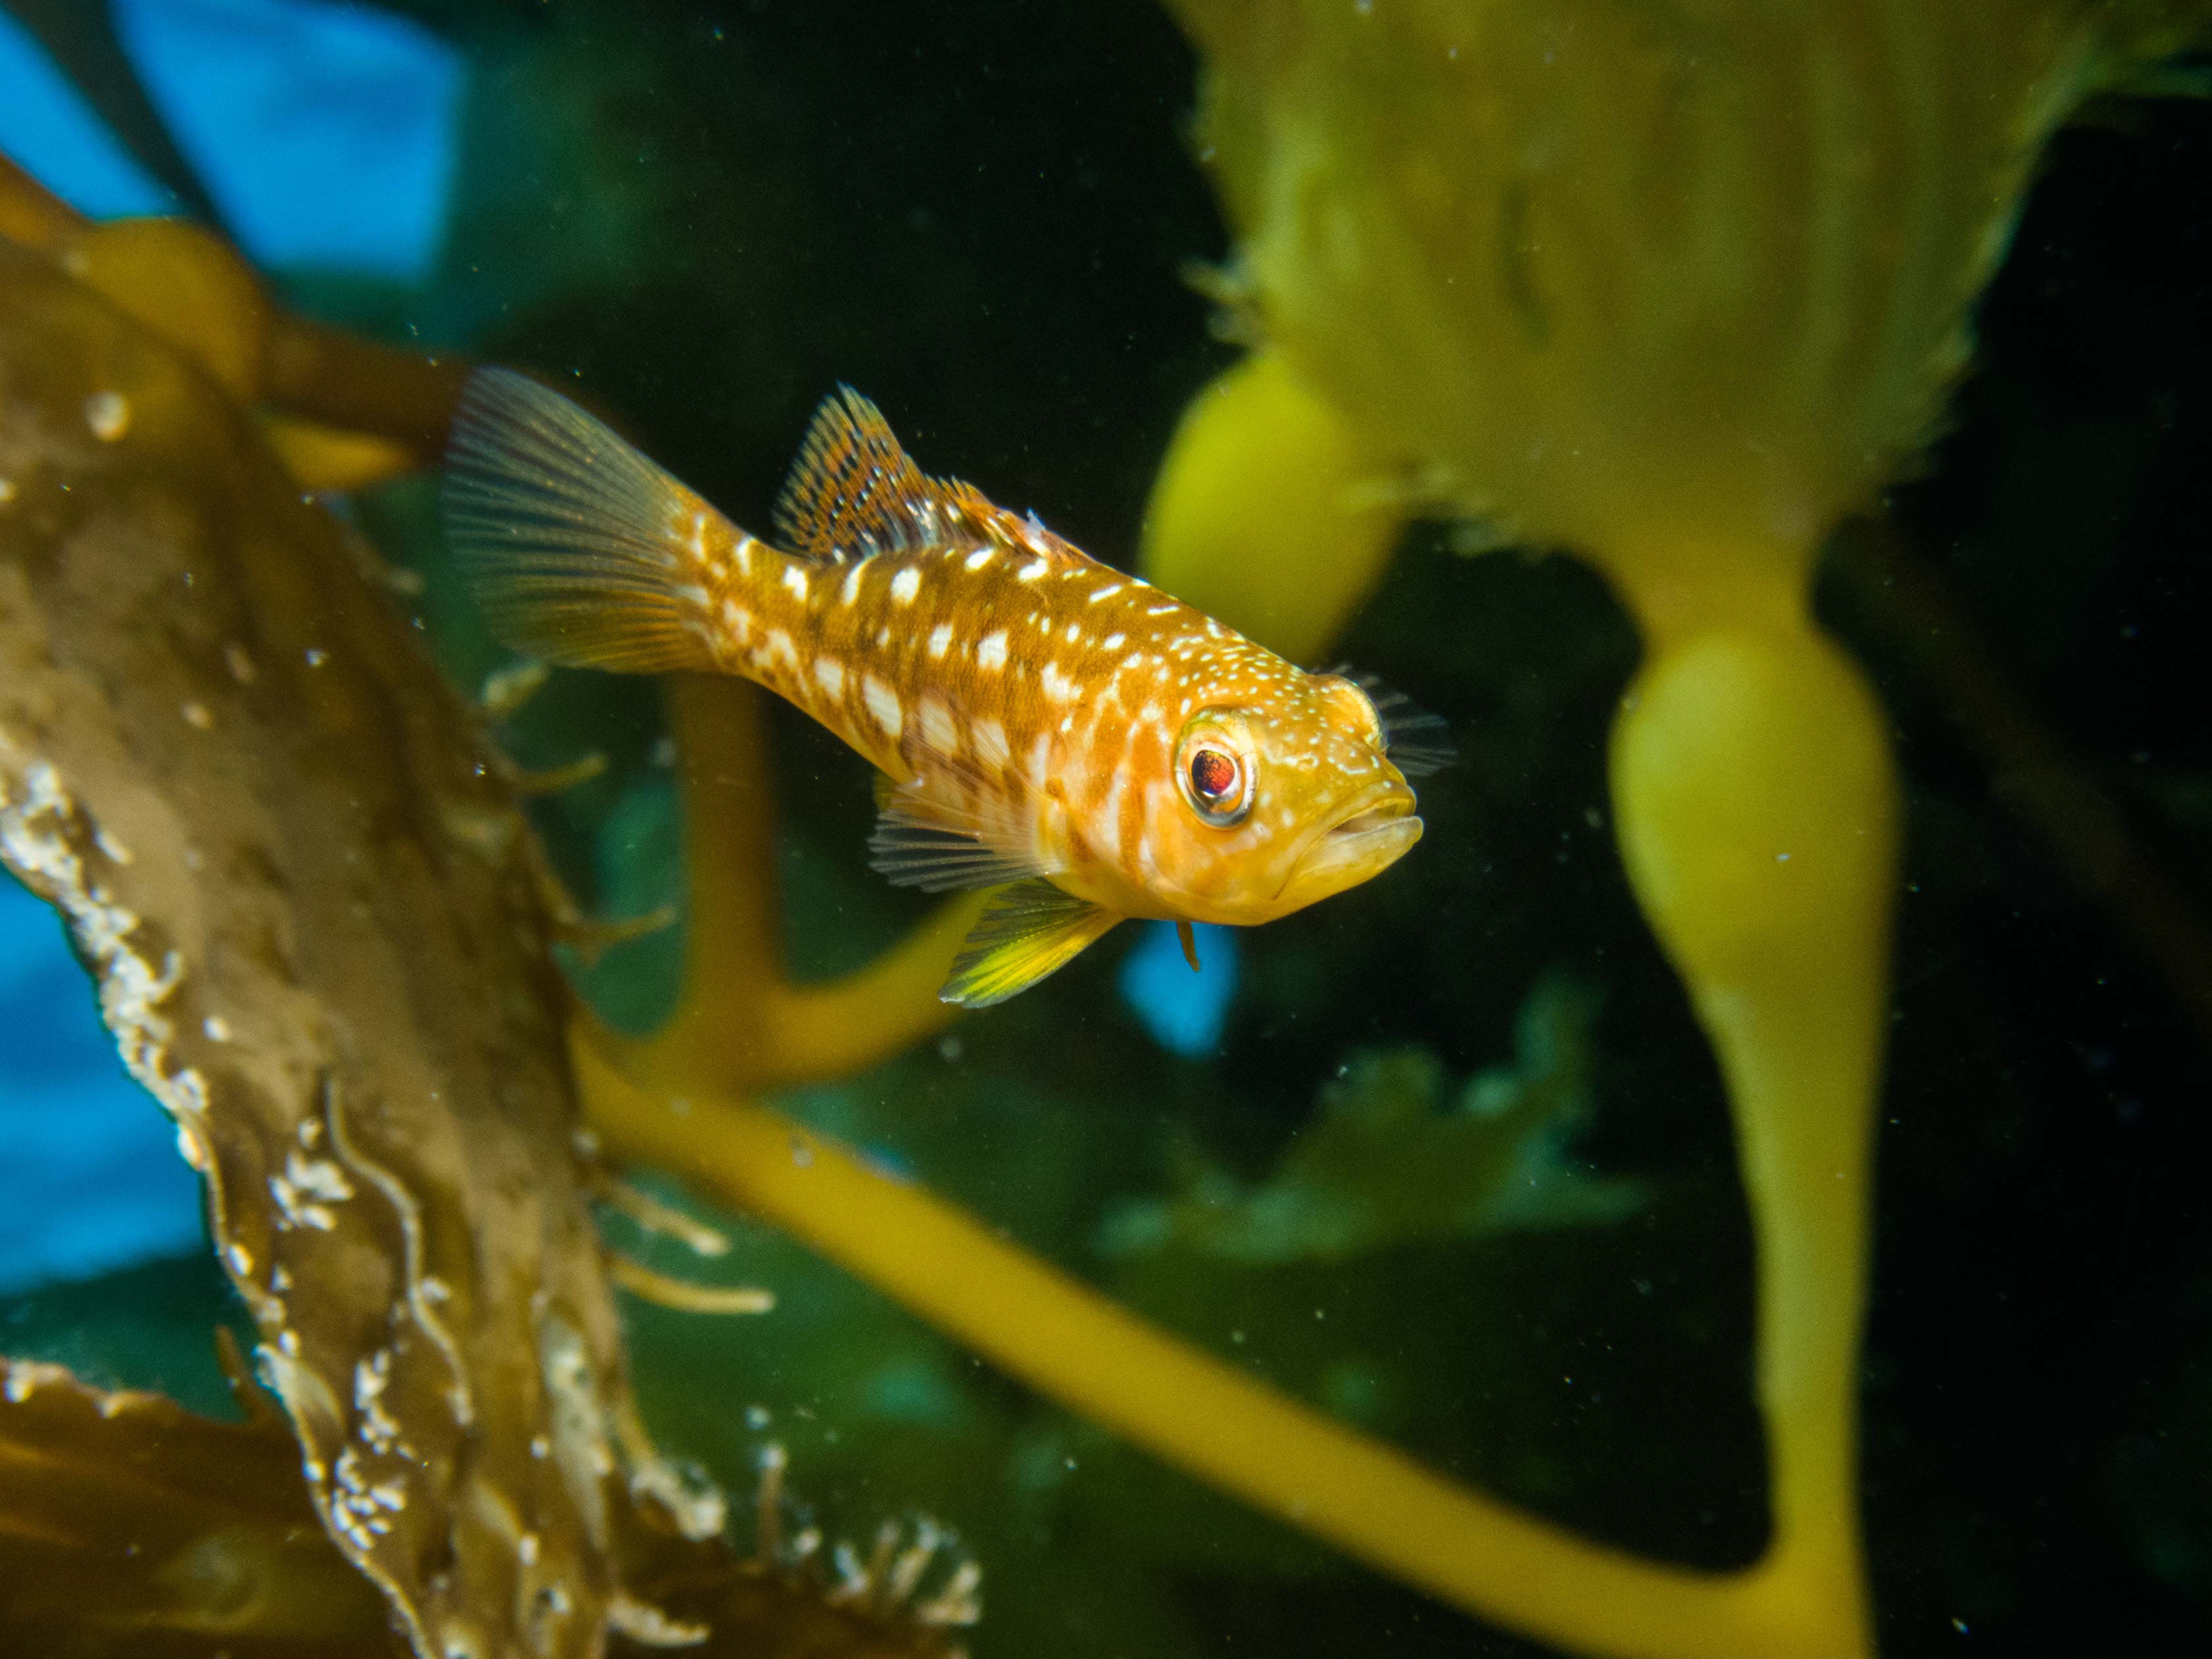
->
776, 385, 995, 564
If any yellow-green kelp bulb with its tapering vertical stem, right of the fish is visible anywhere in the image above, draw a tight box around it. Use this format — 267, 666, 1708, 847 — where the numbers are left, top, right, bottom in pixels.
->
1610, 562, 1898, 1652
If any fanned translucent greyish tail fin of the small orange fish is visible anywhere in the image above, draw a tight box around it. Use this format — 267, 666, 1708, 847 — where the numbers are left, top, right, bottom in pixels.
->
444, 369, 737, 675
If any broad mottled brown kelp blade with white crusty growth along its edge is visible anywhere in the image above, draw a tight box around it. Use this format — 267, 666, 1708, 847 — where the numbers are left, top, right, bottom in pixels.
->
0, 177, 964, 1657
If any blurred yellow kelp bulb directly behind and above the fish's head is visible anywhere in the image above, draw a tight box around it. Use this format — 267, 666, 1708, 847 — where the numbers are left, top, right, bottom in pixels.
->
1144, 352, 1409, 668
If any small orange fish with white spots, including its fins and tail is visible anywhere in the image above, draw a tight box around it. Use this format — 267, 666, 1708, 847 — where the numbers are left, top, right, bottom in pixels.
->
444, 369, 1449, 1007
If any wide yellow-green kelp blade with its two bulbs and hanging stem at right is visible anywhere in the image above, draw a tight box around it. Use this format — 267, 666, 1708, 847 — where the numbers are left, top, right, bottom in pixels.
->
1148, 0, 2203, 1654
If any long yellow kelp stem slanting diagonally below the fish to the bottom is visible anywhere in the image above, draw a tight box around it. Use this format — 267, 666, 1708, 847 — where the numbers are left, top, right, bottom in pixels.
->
575, 1033, 1854, 1659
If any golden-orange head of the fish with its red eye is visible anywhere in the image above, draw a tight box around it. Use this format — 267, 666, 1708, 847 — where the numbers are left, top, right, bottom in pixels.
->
1148, 670, 1422, 927
